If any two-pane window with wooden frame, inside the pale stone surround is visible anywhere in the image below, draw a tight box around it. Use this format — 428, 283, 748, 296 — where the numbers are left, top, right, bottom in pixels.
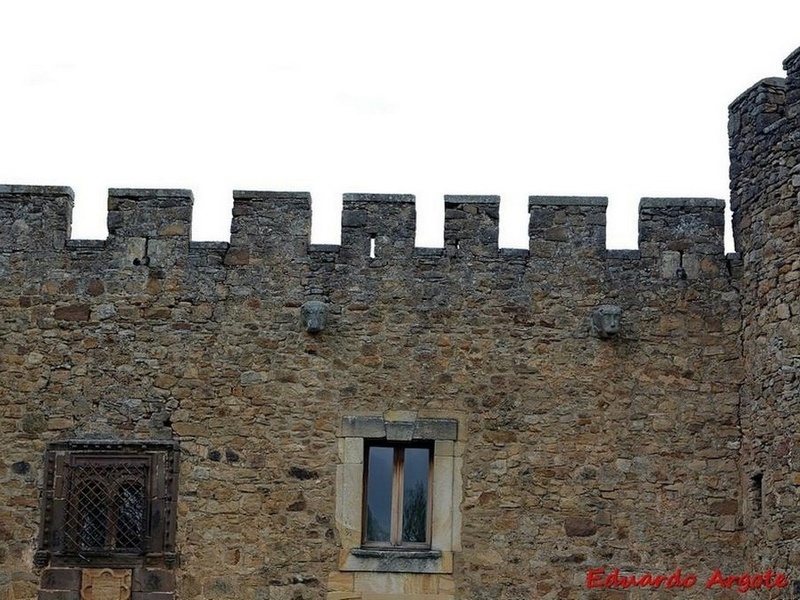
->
361, 442, 433, 548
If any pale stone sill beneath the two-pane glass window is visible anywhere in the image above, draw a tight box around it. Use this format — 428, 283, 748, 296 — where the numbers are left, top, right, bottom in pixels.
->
340, 548, 453, 573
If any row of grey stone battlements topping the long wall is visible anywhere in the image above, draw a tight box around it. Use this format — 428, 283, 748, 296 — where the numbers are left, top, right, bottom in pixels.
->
0, 185, 725, 278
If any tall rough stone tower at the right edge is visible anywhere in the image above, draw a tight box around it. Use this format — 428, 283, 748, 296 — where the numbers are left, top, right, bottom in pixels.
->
730, 51, 800, 568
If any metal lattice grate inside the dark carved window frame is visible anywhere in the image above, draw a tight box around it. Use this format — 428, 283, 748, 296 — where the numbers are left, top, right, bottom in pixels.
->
65, 461, 147, 552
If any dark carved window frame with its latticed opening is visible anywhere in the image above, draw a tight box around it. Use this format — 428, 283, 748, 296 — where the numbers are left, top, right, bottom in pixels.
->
36, 440, 179, 567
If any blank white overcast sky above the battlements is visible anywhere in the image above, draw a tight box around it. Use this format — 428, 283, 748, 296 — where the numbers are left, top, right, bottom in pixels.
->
0, 0, 800, 249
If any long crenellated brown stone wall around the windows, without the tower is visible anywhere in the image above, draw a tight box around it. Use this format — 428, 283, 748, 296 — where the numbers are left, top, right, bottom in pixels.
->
0, 180, 744, 600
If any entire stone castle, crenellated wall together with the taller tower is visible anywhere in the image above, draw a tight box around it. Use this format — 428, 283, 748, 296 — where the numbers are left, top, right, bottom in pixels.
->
0, 43, 800, 600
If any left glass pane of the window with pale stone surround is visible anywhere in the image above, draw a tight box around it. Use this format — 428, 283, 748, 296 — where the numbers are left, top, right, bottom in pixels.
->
364, 446, 394, 542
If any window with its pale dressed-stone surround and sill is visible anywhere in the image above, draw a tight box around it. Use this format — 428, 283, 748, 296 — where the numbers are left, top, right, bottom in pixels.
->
336, 411, 466, 574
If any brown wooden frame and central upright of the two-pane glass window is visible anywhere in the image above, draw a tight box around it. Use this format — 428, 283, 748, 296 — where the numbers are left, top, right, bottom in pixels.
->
361, 440, 434, 550
